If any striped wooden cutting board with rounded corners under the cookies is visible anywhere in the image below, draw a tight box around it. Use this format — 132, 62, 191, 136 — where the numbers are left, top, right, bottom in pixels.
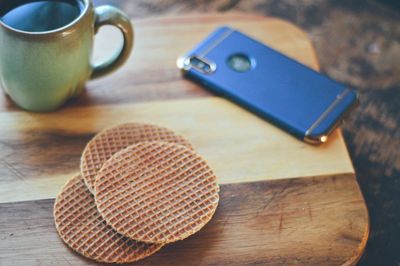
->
0, 14, 369, 265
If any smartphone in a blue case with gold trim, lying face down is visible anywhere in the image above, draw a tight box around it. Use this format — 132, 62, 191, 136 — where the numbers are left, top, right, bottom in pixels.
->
177, 27, 358, 144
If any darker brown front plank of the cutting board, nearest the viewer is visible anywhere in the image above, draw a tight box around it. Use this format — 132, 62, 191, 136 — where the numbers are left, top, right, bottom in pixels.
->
0, 175, 367, 265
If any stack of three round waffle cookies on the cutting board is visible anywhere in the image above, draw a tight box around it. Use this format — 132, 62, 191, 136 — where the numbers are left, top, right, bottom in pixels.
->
54, 123, 219, 263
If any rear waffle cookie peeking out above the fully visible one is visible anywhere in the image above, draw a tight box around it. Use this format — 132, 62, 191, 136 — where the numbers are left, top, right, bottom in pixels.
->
81, 123, 193, 193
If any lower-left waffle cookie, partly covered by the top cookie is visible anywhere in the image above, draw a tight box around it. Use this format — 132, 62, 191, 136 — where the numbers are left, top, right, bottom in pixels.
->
54, 175, 162, 263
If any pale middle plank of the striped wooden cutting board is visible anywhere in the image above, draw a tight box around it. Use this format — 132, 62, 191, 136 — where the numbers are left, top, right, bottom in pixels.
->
0, 97, 354, 203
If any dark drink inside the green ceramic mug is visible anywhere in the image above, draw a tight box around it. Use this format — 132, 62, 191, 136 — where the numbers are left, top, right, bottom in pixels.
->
0, 0, 84, 32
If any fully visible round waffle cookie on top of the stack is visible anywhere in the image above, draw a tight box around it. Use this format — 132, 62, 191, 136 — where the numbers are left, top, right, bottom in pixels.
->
95, 142, 219, 244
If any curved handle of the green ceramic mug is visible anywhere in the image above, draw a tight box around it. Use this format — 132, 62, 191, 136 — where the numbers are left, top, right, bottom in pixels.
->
90, 6, 134, 79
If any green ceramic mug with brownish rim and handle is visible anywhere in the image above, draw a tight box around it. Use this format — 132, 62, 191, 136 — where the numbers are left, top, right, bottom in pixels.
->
0, 0, 134, 112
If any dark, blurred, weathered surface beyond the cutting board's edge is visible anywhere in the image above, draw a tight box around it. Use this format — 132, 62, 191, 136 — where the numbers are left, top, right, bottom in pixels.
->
94, 0, 400, 266
